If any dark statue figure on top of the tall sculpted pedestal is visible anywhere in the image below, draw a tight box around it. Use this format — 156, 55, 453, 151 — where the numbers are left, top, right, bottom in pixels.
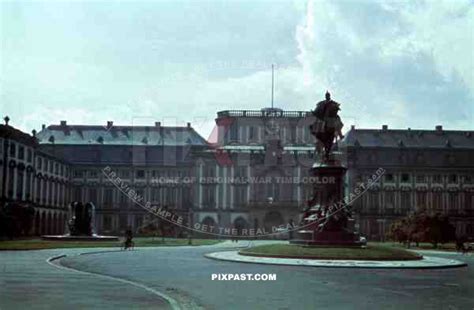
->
310, 91, 344, 162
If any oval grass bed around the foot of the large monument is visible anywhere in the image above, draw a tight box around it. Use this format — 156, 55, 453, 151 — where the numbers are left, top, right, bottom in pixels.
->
239, 244, 422, 260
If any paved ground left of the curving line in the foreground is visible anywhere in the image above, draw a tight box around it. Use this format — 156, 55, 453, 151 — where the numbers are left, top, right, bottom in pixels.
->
0, 249, 169, 310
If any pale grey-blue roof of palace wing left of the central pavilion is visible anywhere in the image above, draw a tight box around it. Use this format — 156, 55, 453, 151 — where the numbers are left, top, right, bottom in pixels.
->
36, 125, 207, 146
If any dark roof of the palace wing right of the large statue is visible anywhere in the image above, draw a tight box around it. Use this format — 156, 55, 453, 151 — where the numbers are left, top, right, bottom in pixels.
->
342, 128, 474, 149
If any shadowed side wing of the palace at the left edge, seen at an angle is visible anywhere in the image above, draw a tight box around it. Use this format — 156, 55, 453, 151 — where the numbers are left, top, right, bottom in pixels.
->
0, 118, 71, 235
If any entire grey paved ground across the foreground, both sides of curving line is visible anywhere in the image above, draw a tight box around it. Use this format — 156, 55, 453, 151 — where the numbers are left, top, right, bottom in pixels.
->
0, 243, 474, 309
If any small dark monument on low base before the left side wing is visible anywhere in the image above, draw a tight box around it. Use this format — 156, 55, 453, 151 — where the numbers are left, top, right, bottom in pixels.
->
68, 201, 94, 236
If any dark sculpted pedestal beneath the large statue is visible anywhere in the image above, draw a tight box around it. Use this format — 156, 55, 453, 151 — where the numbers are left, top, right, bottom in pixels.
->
290, 157, 365, 246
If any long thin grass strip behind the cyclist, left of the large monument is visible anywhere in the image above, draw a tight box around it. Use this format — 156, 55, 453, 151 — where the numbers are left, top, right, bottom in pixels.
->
0, 237, 221, 251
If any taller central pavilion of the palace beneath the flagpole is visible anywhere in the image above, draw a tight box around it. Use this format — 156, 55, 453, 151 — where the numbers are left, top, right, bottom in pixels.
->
196, 108, 314, 233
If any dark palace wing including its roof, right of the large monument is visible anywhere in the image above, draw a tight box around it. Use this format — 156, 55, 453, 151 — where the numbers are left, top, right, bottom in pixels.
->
343, 125, 474, 240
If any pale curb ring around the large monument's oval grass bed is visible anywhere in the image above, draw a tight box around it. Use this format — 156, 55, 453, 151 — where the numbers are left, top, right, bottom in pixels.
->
204, 251, 467, 269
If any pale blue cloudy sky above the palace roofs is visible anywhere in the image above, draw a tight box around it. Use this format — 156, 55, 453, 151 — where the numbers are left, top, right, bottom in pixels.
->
0, 0, 474, 137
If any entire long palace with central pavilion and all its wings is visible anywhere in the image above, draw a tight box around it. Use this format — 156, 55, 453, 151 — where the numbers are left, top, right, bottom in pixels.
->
0, 114, 474, 240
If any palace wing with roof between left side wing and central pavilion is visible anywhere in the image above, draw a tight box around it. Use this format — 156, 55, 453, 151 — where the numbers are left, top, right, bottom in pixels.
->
37, 121, 207, 234
